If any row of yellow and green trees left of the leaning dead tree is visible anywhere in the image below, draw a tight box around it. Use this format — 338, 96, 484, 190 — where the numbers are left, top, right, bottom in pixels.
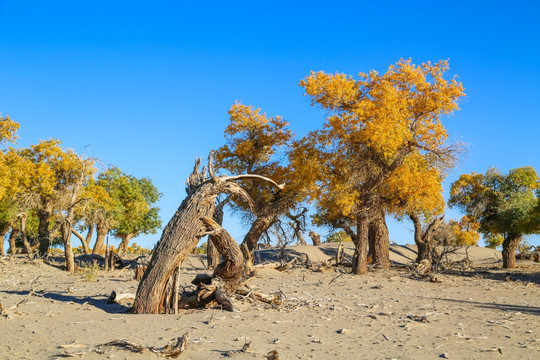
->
0, 116, 161, 272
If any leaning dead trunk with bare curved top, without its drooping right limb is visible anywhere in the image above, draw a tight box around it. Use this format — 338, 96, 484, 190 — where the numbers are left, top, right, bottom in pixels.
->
132, 154, 282, 314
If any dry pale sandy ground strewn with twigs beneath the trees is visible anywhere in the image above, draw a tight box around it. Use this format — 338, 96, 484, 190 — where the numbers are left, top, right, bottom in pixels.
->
0, 244, 540, 359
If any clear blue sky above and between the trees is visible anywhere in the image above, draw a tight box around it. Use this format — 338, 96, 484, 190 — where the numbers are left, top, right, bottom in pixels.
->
0, 0, 540, 246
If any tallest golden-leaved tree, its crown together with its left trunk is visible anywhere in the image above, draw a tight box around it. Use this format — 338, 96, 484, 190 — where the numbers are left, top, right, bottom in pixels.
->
300, 60, 464, 274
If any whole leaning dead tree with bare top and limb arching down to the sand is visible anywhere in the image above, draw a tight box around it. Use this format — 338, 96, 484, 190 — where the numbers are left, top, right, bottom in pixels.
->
132, 153, 283, 314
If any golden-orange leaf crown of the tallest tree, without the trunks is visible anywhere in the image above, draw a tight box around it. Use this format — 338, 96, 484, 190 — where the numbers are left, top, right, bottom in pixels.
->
298, 60, 465, 222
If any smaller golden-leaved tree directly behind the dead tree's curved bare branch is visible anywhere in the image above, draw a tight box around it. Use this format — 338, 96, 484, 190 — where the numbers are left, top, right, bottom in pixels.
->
216, 102, 304, 258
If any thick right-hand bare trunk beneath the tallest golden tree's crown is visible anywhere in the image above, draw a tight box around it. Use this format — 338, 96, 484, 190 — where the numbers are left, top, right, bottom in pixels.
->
368, 209, 390, 269
